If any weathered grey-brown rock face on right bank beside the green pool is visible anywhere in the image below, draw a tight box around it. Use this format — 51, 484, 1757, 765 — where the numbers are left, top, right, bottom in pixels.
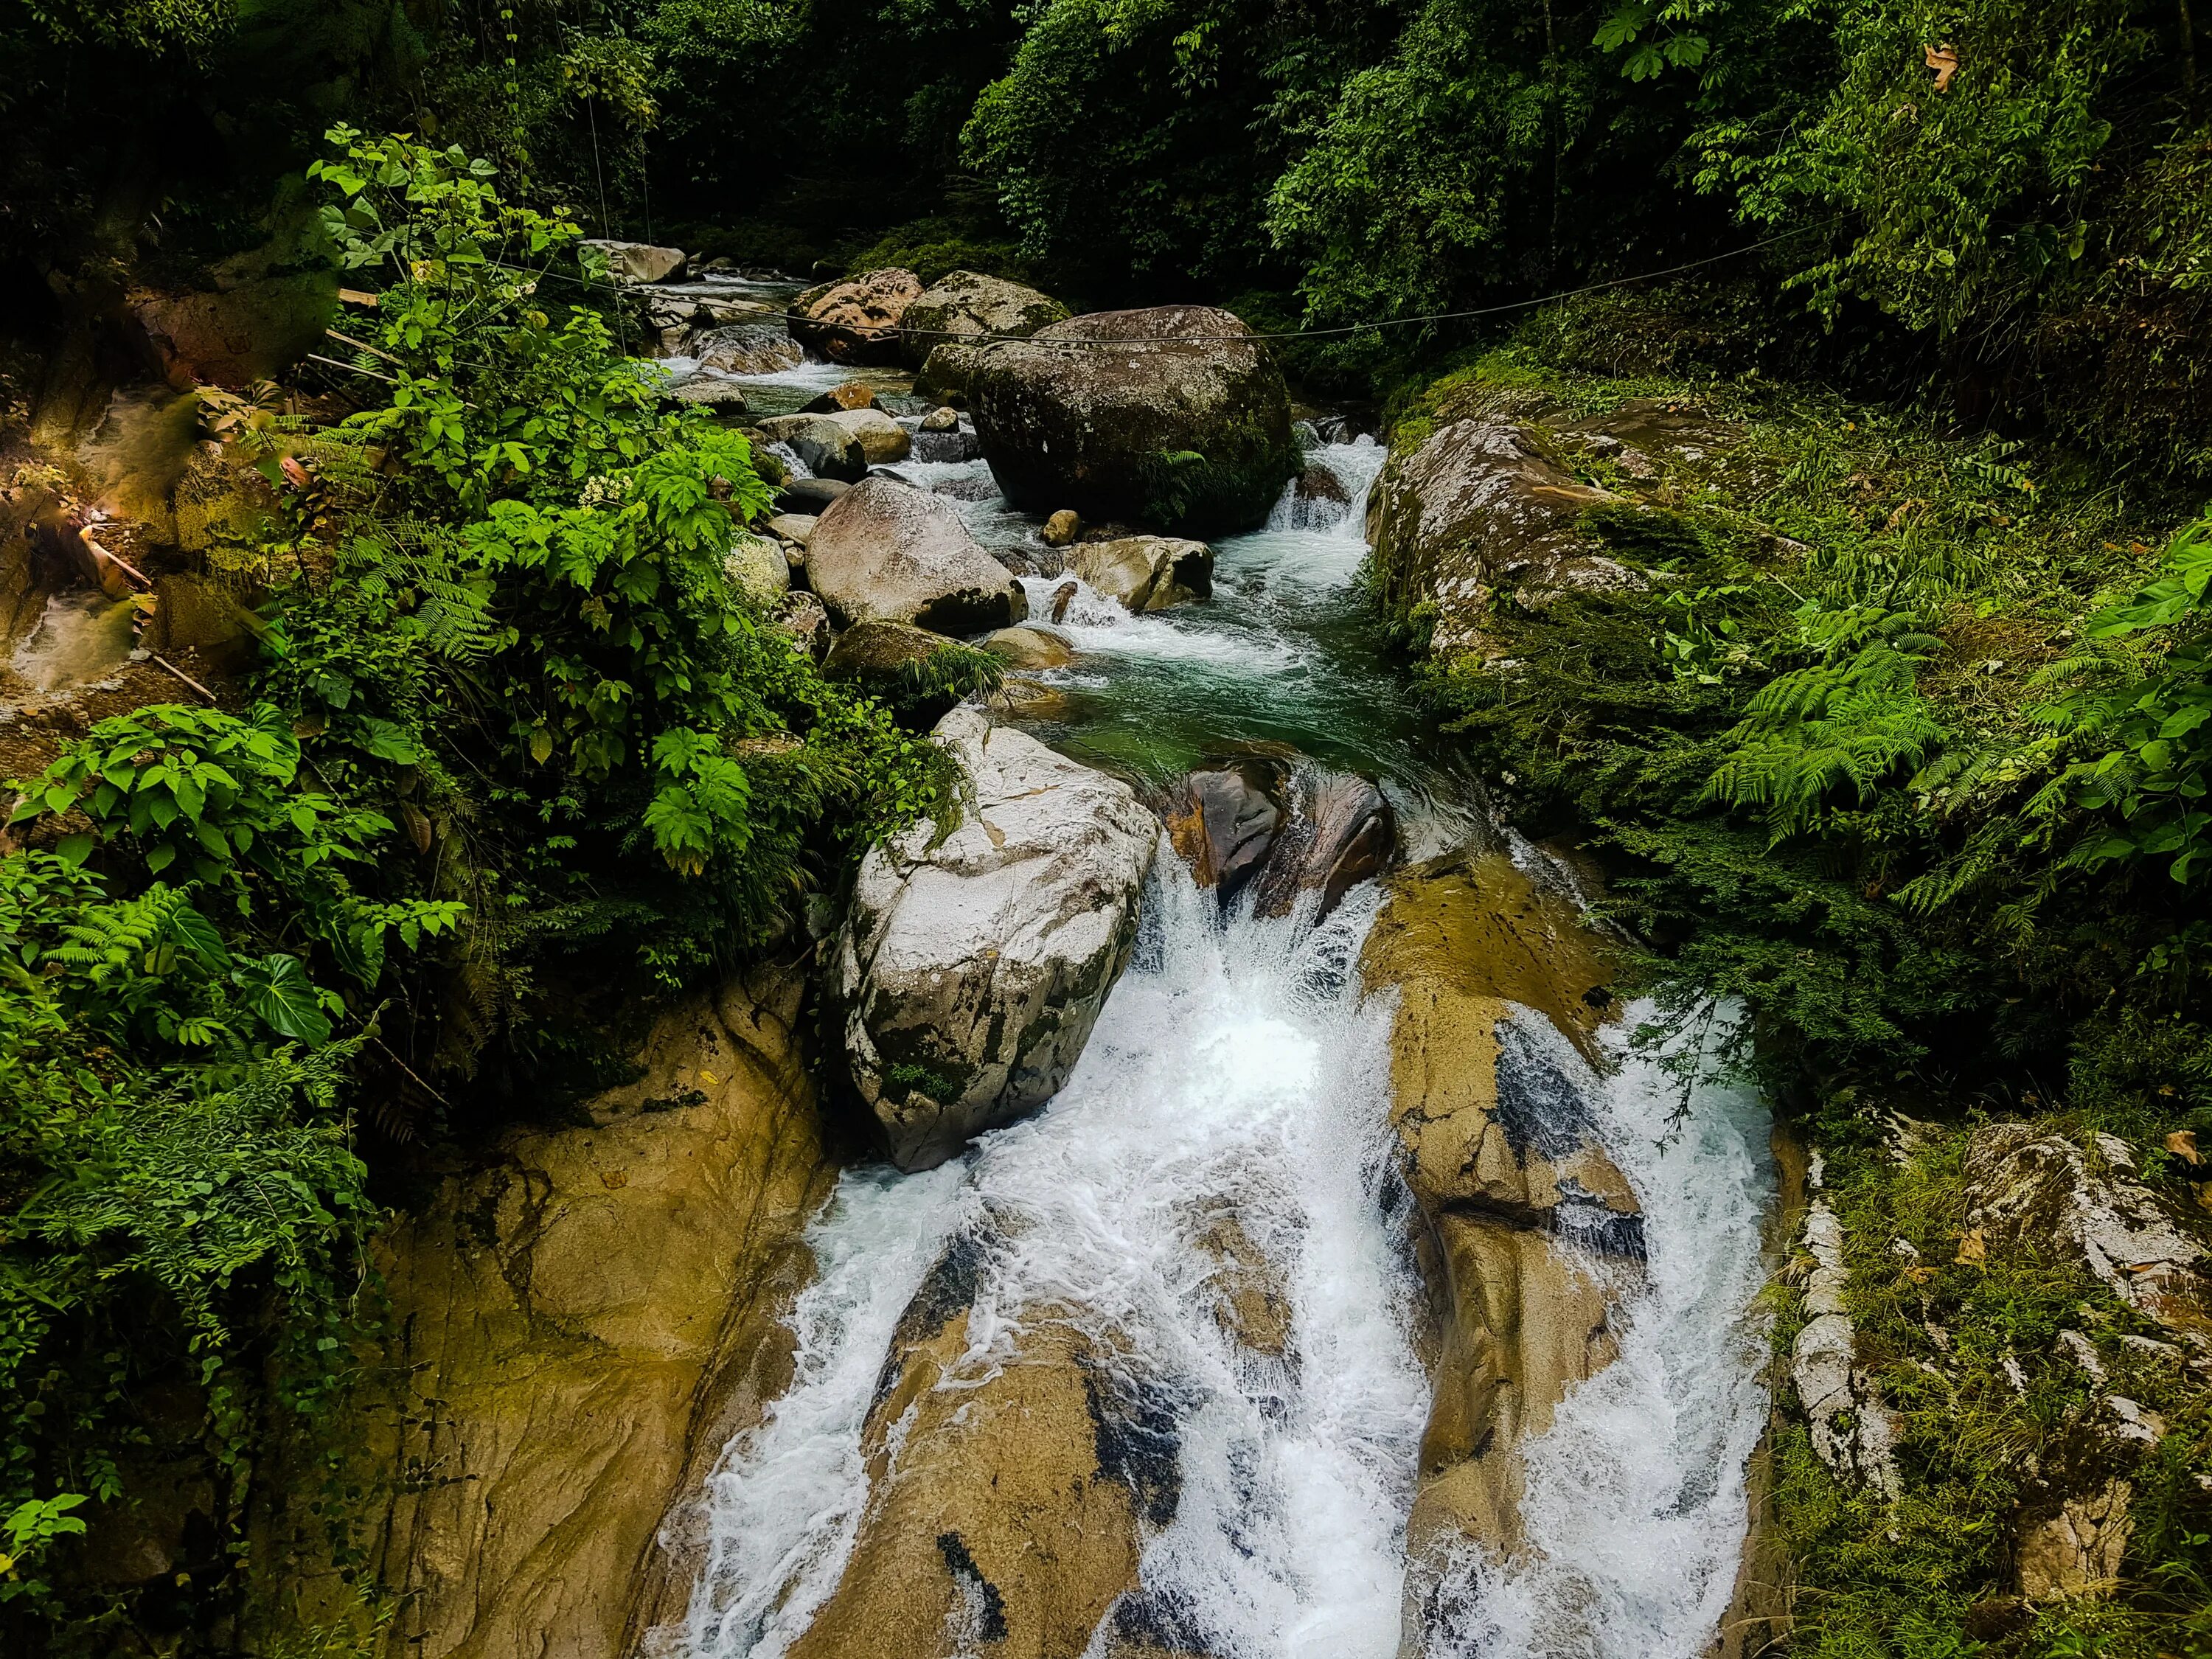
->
1367, 418, 1639, 659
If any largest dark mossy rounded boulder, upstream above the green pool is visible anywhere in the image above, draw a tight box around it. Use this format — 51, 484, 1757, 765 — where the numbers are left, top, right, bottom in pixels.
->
969, 305, 1298, 535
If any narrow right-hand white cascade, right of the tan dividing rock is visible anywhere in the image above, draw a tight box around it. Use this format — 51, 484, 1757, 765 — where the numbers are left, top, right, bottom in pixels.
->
1427, 1004, 1774, 1659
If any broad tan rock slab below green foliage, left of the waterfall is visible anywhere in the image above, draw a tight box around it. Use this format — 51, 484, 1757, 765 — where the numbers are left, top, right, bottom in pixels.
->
272, 969, 836, 1659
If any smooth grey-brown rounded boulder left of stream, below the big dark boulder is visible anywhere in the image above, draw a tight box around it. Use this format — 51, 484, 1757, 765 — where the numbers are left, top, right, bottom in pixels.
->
807, 473, 1029, 635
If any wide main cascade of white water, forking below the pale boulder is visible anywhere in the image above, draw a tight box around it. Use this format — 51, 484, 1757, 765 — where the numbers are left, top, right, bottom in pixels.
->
690, 872, 1427, 1659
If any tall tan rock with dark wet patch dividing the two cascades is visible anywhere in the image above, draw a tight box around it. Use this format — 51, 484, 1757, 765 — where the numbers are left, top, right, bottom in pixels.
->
1360, 856, 1644, 1628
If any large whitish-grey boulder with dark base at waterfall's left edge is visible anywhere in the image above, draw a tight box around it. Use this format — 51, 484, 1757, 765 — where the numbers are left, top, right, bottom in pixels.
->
830, 706, 1159, 1170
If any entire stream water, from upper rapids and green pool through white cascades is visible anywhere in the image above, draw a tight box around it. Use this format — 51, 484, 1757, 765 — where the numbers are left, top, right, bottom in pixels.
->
659, 332, 1774, 1659
